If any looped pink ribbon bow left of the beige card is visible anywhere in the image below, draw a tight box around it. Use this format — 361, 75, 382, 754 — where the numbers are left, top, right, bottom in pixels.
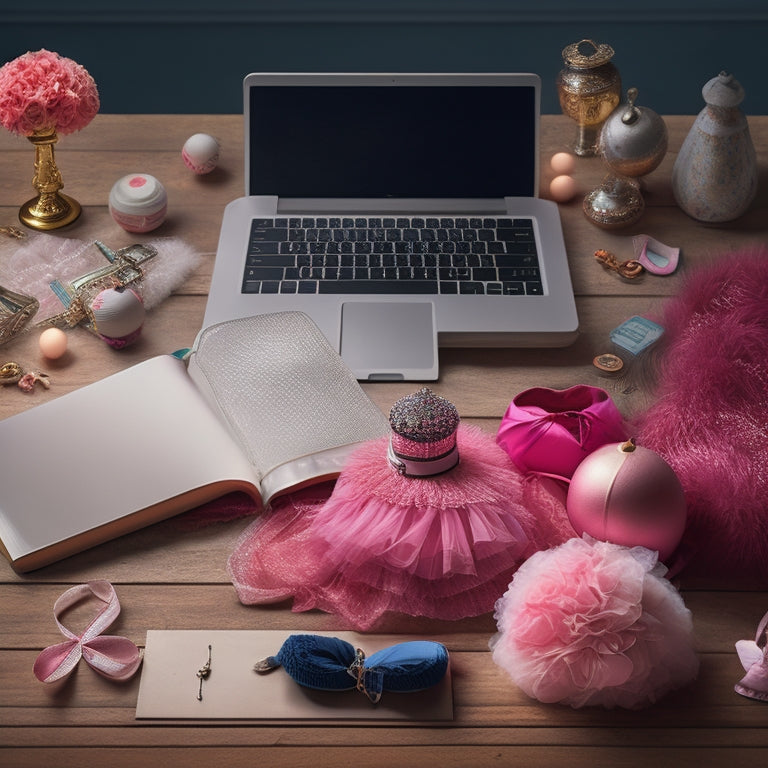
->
34, 580, 142, 683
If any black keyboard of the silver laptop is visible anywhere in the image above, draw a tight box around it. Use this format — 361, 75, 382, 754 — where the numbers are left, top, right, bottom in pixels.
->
242, 216, 543, 295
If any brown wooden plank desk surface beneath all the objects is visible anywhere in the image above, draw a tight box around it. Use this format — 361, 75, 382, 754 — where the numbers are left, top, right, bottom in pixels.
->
0, 115, 768, 768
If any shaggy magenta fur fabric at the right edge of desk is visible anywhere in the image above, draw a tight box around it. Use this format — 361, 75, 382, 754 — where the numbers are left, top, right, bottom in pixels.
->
636, 248, 768, 579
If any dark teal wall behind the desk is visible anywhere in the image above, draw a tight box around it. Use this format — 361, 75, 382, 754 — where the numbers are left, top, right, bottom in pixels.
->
6, 0, 768, 114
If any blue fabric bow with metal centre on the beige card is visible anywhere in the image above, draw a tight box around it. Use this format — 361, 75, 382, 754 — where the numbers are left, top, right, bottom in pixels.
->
254, 635, 448, 703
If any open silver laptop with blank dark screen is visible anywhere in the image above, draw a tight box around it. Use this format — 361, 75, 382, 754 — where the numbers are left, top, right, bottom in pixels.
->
204, 73, 578, 381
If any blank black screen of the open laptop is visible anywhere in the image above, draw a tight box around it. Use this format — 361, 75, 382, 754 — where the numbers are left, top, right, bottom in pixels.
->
246, 84, 538, 198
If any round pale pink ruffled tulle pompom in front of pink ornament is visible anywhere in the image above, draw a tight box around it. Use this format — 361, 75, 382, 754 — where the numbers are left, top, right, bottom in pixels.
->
490, 538, 699, 709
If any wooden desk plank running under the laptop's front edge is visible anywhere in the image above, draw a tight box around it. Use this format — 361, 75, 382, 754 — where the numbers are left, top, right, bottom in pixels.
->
0, 294, 672, 419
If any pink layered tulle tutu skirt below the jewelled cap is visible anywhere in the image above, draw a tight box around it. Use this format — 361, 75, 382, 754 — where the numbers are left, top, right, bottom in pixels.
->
229, 425, 554, 630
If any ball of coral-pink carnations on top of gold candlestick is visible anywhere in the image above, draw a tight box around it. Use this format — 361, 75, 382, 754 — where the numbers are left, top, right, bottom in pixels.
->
0, 49, 99, 136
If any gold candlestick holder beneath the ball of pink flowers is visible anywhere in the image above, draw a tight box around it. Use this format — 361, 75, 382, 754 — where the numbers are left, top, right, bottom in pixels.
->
19, 128, 81, 230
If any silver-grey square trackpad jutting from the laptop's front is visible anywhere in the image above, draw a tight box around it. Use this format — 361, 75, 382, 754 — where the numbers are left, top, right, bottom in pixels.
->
341, 301, 438, 381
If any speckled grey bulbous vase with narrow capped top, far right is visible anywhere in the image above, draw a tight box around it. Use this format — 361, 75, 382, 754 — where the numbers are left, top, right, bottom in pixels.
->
672, 72, 757, 223
